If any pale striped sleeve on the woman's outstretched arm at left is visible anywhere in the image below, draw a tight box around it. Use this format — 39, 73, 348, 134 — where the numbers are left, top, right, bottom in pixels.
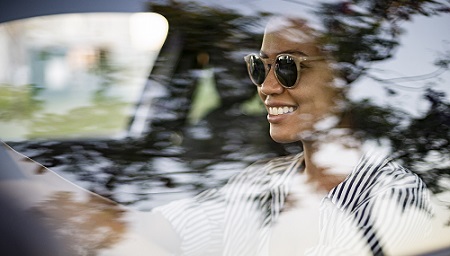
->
153, 159, 270, 256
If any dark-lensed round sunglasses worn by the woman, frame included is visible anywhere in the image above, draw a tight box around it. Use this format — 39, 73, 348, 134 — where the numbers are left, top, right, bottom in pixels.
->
244, 54, 325, 89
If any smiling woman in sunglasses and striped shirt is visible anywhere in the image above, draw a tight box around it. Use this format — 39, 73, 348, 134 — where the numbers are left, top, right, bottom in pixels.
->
153, 18, 431, 255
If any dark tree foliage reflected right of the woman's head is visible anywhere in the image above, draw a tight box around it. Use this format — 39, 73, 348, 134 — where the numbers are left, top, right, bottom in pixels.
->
318, 0, 450, 196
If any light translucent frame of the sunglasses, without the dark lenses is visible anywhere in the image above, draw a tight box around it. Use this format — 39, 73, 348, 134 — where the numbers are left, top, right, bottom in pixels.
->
244, 53, 325, 89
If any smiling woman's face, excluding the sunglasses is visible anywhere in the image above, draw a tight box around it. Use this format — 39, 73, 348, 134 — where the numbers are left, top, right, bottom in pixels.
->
258, 21, 337, 143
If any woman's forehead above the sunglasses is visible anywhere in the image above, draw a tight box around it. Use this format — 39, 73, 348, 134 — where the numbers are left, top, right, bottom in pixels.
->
261, 19, 319, 56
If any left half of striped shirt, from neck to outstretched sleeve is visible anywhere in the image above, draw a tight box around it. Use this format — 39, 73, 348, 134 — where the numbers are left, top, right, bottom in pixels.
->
149, 157, 298, 256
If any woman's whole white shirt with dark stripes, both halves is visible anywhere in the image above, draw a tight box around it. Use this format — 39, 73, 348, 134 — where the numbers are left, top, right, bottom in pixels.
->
154, 154, 432, 256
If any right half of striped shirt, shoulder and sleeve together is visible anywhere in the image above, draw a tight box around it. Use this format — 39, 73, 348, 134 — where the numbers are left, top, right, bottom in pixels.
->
314, 154, 433, 255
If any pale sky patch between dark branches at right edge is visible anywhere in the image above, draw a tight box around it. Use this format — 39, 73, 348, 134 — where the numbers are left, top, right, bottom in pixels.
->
351, 15, 450, 116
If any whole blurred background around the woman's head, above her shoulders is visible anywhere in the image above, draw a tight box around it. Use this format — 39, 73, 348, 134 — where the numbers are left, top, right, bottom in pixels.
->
0, 0, 450, 213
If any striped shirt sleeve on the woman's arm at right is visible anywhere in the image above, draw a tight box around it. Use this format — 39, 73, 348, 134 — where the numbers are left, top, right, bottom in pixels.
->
355, 162, 434, 255
